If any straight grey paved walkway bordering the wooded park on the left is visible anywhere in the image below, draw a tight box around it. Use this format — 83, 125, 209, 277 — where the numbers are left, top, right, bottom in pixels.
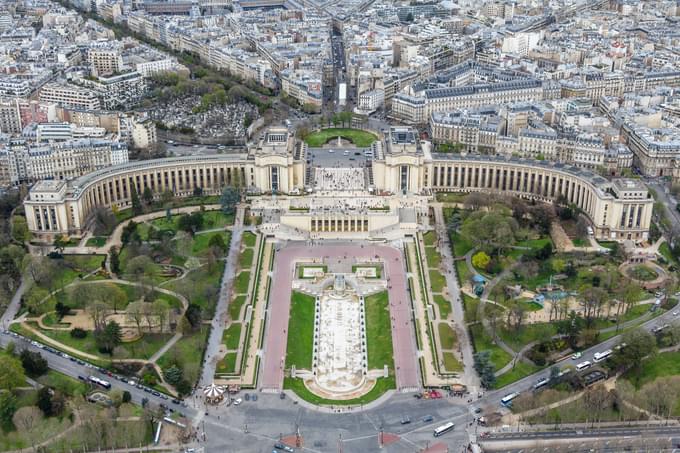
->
198, 206, 245, 387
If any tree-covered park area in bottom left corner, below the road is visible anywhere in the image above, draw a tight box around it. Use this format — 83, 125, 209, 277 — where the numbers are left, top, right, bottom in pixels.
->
0, 346, 153, 452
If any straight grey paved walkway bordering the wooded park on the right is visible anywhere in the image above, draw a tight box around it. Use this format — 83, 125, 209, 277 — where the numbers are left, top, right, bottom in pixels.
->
432, 203, 480, 393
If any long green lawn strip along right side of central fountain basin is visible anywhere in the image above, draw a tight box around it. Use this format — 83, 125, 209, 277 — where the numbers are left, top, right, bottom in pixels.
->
364, 291, 394, 370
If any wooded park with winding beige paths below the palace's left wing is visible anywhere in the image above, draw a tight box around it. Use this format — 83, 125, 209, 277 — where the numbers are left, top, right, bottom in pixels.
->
11, 202, 238, 394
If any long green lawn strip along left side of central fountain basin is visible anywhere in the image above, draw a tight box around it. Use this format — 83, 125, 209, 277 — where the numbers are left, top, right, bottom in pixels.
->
286, 291, 315, 370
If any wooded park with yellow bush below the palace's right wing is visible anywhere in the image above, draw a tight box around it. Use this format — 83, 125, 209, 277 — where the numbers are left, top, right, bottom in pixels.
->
440, 194, 663, 388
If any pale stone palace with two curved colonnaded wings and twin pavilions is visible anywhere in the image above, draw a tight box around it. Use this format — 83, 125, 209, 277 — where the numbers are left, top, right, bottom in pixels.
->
24, 123, 653, 241
